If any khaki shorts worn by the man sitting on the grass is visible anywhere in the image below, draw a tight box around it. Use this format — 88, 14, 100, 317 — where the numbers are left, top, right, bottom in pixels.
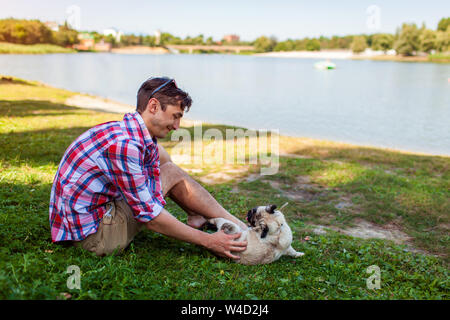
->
75, 200, 144, 256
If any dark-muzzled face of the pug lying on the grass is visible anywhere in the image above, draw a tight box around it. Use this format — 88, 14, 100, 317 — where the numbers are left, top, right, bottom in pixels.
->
247, 204, 286, 238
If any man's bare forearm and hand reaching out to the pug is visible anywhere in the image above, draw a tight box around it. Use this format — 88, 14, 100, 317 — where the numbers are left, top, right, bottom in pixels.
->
145, 209, 247, 259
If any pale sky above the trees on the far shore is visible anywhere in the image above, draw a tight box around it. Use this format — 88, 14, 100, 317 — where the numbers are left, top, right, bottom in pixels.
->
0, 0, 450, 41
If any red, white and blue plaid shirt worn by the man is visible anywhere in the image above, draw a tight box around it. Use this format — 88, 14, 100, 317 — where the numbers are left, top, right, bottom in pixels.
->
49, 112, 166, 242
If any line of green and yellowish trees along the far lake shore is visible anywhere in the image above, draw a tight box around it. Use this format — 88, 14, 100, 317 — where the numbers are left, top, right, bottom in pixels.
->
0, 17, 450, 55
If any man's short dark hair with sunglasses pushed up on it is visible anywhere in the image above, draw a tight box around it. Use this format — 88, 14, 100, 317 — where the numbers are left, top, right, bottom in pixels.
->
136, 78, 192, 113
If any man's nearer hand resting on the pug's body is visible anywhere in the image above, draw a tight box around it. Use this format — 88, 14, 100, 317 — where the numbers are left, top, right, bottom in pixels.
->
205, 230, 247, 260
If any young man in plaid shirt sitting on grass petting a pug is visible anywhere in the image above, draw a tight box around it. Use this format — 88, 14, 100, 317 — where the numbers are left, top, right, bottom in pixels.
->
50, 78, 247, 259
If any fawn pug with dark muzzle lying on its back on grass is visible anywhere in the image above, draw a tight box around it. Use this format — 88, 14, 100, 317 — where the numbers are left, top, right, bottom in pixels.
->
208, 203, 304, 265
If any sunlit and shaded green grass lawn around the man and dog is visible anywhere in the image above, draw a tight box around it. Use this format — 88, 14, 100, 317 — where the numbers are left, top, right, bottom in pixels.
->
0, 78, 450, 299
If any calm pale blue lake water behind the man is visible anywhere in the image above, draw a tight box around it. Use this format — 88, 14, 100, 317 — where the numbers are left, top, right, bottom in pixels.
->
0, 53, 450, 155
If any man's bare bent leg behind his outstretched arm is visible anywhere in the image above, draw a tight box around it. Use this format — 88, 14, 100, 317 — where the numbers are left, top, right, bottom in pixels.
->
159, 146, 247, 230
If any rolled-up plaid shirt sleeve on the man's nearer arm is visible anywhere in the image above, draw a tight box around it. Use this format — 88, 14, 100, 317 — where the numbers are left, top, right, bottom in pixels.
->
99, 141, 165, 223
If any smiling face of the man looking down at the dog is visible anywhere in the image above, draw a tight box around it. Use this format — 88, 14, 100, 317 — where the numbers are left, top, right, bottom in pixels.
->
144, 101, 184, 138
